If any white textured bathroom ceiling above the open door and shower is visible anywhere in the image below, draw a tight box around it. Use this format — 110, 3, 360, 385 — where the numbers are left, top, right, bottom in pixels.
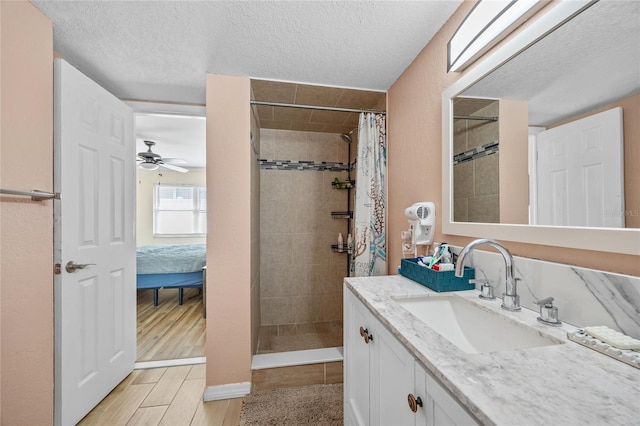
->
32, 0, 461, 104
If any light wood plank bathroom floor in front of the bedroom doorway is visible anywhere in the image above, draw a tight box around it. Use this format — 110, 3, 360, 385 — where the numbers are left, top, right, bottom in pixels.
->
79, 364, 242, 426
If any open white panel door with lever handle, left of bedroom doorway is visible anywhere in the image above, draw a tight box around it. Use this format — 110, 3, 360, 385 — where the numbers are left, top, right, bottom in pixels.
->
54, 59, 136, 425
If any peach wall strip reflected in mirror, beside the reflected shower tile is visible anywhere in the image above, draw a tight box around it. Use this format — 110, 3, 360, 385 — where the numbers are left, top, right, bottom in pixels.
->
498, 99, 529, 224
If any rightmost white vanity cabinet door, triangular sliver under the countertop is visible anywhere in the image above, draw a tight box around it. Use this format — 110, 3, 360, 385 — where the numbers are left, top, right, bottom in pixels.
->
415, 362, 478, 426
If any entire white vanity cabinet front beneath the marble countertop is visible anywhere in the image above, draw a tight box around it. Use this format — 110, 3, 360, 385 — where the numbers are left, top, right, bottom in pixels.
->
344, 287, 477, 426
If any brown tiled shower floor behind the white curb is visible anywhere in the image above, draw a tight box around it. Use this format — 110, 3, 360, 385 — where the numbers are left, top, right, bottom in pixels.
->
257, 320, 342, 354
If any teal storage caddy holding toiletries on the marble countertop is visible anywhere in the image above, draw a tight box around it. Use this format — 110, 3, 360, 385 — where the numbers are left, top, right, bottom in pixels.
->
400, 259, 476, 292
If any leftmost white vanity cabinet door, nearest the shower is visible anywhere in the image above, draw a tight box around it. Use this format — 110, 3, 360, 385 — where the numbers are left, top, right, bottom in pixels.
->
344, 287, 371, 426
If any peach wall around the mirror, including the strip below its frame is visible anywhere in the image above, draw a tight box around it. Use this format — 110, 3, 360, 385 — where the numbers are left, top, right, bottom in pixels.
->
387, 1, 640, 275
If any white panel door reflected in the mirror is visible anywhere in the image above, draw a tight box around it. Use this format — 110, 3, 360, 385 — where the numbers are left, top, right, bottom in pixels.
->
536, 108, 624, 228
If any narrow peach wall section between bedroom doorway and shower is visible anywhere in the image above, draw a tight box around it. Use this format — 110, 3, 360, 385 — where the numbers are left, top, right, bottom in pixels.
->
206, 74, 253, 386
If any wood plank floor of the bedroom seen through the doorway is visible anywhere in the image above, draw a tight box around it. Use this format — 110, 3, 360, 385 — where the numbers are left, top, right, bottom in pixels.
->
137, 288, 206, 362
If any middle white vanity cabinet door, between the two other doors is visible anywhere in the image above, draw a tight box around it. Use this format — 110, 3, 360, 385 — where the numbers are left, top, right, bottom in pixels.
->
371, 321, 415, 426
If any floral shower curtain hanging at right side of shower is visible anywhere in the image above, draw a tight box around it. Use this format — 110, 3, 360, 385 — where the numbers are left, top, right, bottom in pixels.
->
351, 113, 387, 277
